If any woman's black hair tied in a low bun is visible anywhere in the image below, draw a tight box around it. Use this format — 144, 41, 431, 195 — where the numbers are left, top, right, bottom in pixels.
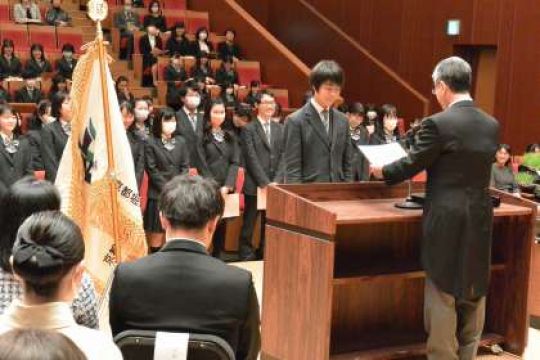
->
12, 211, 84, 300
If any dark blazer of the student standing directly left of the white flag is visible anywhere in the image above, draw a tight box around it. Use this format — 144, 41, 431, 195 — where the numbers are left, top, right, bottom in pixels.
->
41, 120, 68, 182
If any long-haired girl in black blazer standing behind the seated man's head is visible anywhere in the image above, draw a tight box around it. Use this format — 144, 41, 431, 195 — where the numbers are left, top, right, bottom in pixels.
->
202, 98, 240, 257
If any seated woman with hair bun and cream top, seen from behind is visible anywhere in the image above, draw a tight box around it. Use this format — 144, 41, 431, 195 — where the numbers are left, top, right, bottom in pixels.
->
0, 211, 122, 360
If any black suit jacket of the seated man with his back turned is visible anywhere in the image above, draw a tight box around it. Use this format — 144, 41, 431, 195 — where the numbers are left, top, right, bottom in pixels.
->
109, 240, 260, 360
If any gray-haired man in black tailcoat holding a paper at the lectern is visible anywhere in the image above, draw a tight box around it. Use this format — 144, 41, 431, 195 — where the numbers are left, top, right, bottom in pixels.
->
372, 57, 499, 360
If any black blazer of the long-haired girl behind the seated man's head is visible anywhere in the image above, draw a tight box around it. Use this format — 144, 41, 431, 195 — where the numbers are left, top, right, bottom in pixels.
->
202, 132, 240, 189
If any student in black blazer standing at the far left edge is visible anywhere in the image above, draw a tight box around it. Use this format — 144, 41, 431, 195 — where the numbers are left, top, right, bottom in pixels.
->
0, 104, 34, 188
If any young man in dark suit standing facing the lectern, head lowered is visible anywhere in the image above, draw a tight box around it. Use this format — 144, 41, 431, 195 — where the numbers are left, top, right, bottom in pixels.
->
285, 61, 353, 183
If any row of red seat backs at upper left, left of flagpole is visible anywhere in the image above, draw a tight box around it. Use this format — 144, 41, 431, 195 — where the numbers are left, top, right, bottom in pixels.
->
0, 23, 83, 54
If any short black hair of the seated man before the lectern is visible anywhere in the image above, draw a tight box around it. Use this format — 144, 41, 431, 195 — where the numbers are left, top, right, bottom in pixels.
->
159, 175, 225, 230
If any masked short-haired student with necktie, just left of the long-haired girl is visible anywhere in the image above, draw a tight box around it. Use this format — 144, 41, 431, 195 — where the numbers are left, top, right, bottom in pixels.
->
176, 81, 204, 175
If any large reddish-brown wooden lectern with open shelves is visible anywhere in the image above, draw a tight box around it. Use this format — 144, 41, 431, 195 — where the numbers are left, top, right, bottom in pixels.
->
262, 183, 536, 360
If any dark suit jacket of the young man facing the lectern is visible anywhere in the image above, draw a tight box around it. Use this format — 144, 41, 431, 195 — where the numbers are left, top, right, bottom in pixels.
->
285, 102, 353, 183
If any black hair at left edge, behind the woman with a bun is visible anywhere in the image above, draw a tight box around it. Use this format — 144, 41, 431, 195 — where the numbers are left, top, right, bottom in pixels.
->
0, 176, 60, 272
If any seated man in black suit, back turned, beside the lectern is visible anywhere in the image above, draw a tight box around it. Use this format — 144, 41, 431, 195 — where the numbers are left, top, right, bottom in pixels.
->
109, 176, 260, 360
